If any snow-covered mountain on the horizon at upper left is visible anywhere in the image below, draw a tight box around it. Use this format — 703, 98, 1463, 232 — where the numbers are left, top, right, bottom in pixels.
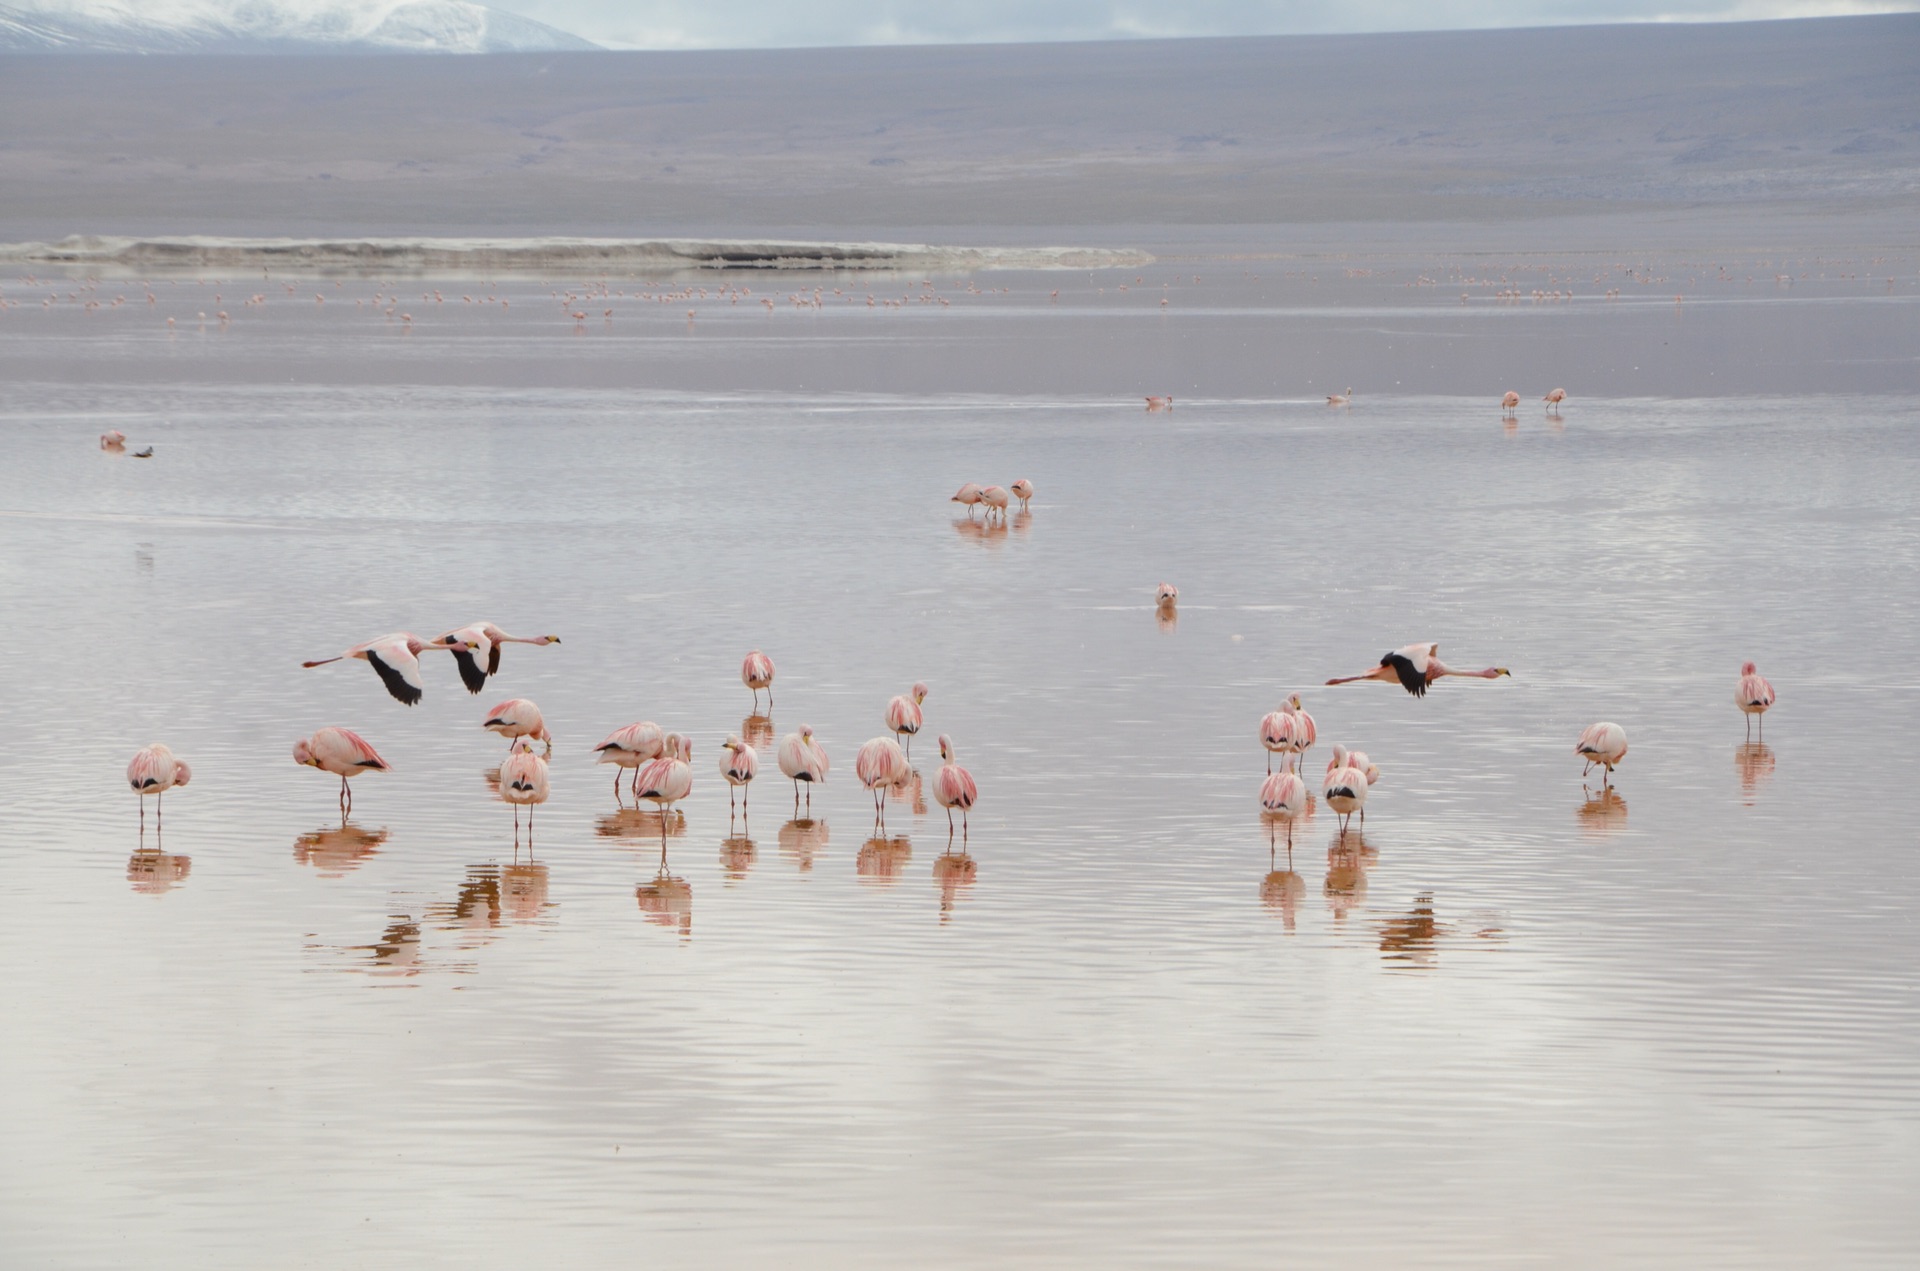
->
0, 0, 597, 54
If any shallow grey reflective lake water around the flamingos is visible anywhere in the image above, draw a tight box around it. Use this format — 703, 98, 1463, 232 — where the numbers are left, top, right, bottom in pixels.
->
0, 263, 1920, 1267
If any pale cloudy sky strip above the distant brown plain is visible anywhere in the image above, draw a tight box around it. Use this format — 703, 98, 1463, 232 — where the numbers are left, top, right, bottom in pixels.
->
492, 0, 1920, 48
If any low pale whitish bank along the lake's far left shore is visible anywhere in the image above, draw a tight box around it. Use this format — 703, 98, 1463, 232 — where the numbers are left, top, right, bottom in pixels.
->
0, 234, 1154, 275
